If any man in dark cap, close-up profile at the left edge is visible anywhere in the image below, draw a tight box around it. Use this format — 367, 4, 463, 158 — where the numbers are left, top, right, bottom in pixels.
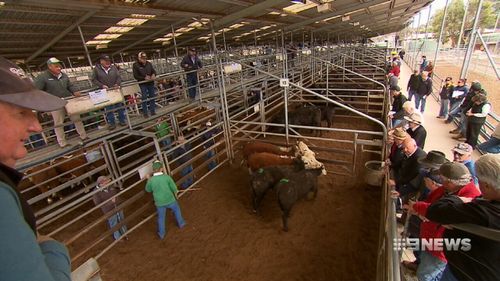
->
0, 57, 71, 281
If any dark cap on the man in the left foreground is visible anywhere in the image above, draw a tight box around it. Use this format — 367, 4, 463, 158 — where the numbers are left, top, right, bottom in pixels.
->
0, 57, 67, 111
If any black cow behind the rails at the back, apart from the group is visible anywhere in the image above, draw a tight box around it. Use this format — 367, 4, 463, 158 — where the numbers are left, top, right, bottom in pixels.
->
271, 106, 321, 135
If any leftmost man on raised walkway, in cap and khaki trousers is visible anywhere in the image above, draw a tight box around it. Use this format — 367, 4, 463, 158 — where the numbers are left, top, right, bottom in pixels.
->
35, 58, 87, 147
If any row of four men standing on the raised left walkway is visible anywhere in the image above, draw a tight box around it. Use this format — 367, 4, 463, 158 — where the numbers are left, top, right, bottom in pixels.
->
31, 48, 202, 148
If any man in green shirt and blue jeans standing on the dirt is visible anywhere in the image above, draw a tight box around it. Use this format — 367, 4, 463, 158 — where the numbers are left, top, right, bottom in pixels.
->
146, 161, 186, 239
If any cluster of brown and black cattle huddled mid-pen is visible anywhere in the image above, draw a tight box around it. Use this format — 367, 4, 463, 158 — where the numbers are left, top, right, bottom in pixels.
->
243, 141, 326, 231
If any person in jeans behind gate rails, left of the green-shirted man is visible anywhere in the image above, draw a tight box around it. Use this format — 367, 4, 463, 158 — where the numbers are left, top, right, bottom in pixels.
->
92, 176, 127, 240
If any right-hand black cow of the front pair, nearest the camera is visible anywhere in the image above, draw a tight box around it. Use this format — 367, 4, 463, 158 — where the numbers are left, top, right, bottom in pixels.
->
274, 166, 322, 231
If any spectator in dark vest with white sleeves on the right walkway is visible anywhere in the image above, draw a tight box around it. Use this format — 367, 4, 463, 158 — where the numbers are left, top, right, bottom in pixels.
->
466, 94, 491, 148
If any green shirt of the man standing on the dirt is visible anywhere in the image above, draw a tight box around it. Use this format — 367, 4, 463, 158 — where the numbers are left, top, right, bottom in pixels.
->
146, 173, 177, 207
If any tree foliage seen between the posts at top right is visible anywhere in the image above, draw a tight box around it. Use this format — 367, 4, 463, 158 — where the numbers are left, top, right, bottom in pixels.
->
431, 0, 497, 47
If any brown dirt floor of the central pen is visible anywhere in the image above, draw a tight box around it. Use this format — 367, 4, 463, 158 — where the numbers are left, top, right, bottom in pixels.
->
95, 117, 381, 281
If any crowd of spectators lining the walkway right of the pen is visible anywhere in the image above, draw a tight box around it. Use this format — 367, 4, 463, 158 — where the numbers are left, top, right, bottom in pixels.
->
386, 50, 500, 281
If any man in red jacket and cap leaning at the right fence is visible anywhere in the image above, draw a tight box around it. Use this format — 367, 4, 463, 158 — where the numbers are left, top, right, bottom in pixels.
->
406, 162, 481, 281
